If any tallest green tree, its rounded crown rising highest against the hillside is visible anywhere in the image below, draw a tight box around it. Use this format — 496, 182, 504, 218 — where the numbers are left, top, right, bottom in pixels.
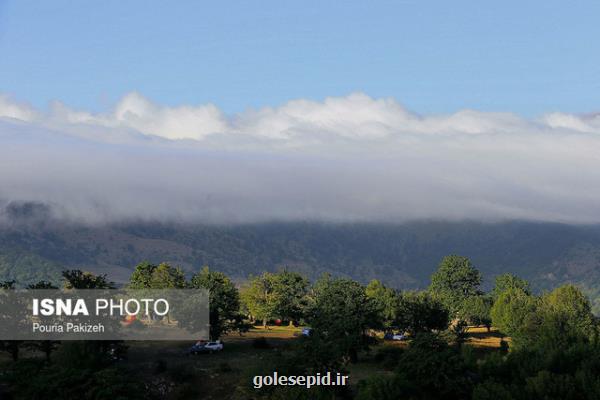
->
429, 255, 481, 316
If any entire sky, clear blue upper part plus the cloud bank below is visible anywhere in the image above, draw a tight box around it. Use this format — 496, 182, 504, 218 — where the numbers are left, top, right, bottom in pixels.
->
0, 0, 600, 225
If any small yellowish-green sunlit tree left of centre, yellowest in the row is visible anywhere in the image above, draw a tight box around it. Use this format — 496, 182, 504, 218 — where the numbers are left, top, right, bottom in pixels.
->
241, 272, 279, 328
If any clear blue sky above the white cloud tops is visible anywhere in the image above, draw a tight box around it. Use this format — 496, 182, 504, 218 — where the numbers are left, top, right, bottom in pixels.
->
0, 0, 600, 116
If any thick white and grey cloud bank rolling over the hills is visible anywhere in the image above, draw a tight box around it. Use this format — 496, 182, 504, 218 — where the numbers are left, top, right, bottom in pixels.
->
0, 93, 600, 223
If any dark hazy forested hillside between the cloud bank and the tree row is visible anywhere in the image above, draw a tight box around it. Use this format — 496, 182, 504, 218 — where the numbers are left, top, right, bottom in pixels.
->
0, 221, 600, 304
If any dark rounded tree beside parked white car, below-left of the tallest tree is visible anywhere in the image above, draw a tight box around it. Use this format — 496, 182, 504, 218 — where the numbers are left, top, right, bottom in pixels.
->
394, 292, 449, 335
